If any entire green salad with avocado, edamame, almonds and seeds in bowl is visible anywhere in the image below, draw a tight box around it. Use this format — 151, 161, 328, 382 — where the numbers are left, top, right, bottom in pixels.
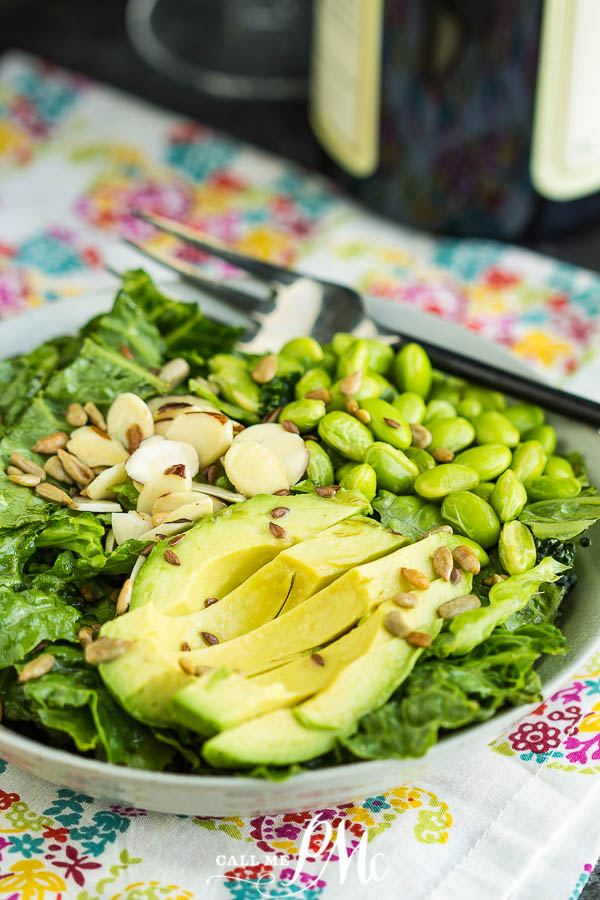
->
0, 270, 600, 778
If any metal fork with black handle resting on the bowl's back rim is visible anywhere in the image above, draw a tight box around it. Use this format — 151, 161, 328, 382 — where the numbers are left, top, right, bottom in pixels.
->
119, 212, 600, 428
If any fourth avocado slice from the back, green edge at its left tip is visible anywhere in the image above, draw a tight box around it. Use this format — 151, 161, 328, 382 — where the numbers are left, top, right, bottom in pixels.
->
171, 573, 472, 735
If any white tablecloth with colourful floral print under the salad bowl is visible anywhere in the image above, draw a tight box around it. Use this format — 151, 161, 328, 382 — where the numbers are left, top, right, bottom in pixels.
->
0, 54, 600, 900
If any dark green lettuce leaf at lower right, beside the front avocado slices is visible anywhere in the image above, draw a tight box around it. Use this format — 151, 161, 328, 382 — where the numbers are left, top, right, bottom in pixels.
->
341, 624, 565, 759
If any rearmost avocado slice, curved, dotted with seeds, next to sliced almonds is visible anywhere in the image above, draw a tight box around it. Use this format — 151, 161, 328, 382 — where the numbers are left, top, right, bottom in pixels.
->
130, 490, 367, 616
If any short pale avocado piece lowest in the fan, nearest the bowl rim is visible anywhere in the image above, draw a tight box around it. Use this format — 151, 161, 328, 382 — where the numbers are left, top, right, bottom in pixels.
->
203, 709, 337, 769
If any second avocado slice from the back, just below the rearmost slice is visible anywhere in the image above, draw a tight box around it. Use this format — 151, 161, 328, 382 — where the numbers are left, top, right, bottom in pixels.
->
109, 516, 408, 651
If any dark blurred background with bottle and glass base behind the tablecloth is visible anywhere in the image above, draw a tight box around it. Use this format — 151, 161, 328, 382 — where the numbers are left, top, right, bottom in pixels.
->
0, 0, 600, 270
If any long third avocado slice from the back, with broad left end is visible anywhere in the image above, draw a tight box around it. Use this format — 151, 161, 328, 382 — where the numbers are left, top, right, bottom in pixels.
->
100, 532, 453, 725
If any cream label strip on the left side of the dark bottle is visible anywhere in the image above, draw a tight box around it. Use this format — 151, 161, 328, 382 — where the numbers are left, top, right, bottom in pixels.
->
310, 0, 383, 177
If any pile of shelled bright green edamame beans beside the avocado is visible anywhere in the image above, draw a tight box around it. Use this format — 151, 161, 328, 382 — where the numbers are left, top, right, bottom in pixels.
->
209, 333, 581, 575
